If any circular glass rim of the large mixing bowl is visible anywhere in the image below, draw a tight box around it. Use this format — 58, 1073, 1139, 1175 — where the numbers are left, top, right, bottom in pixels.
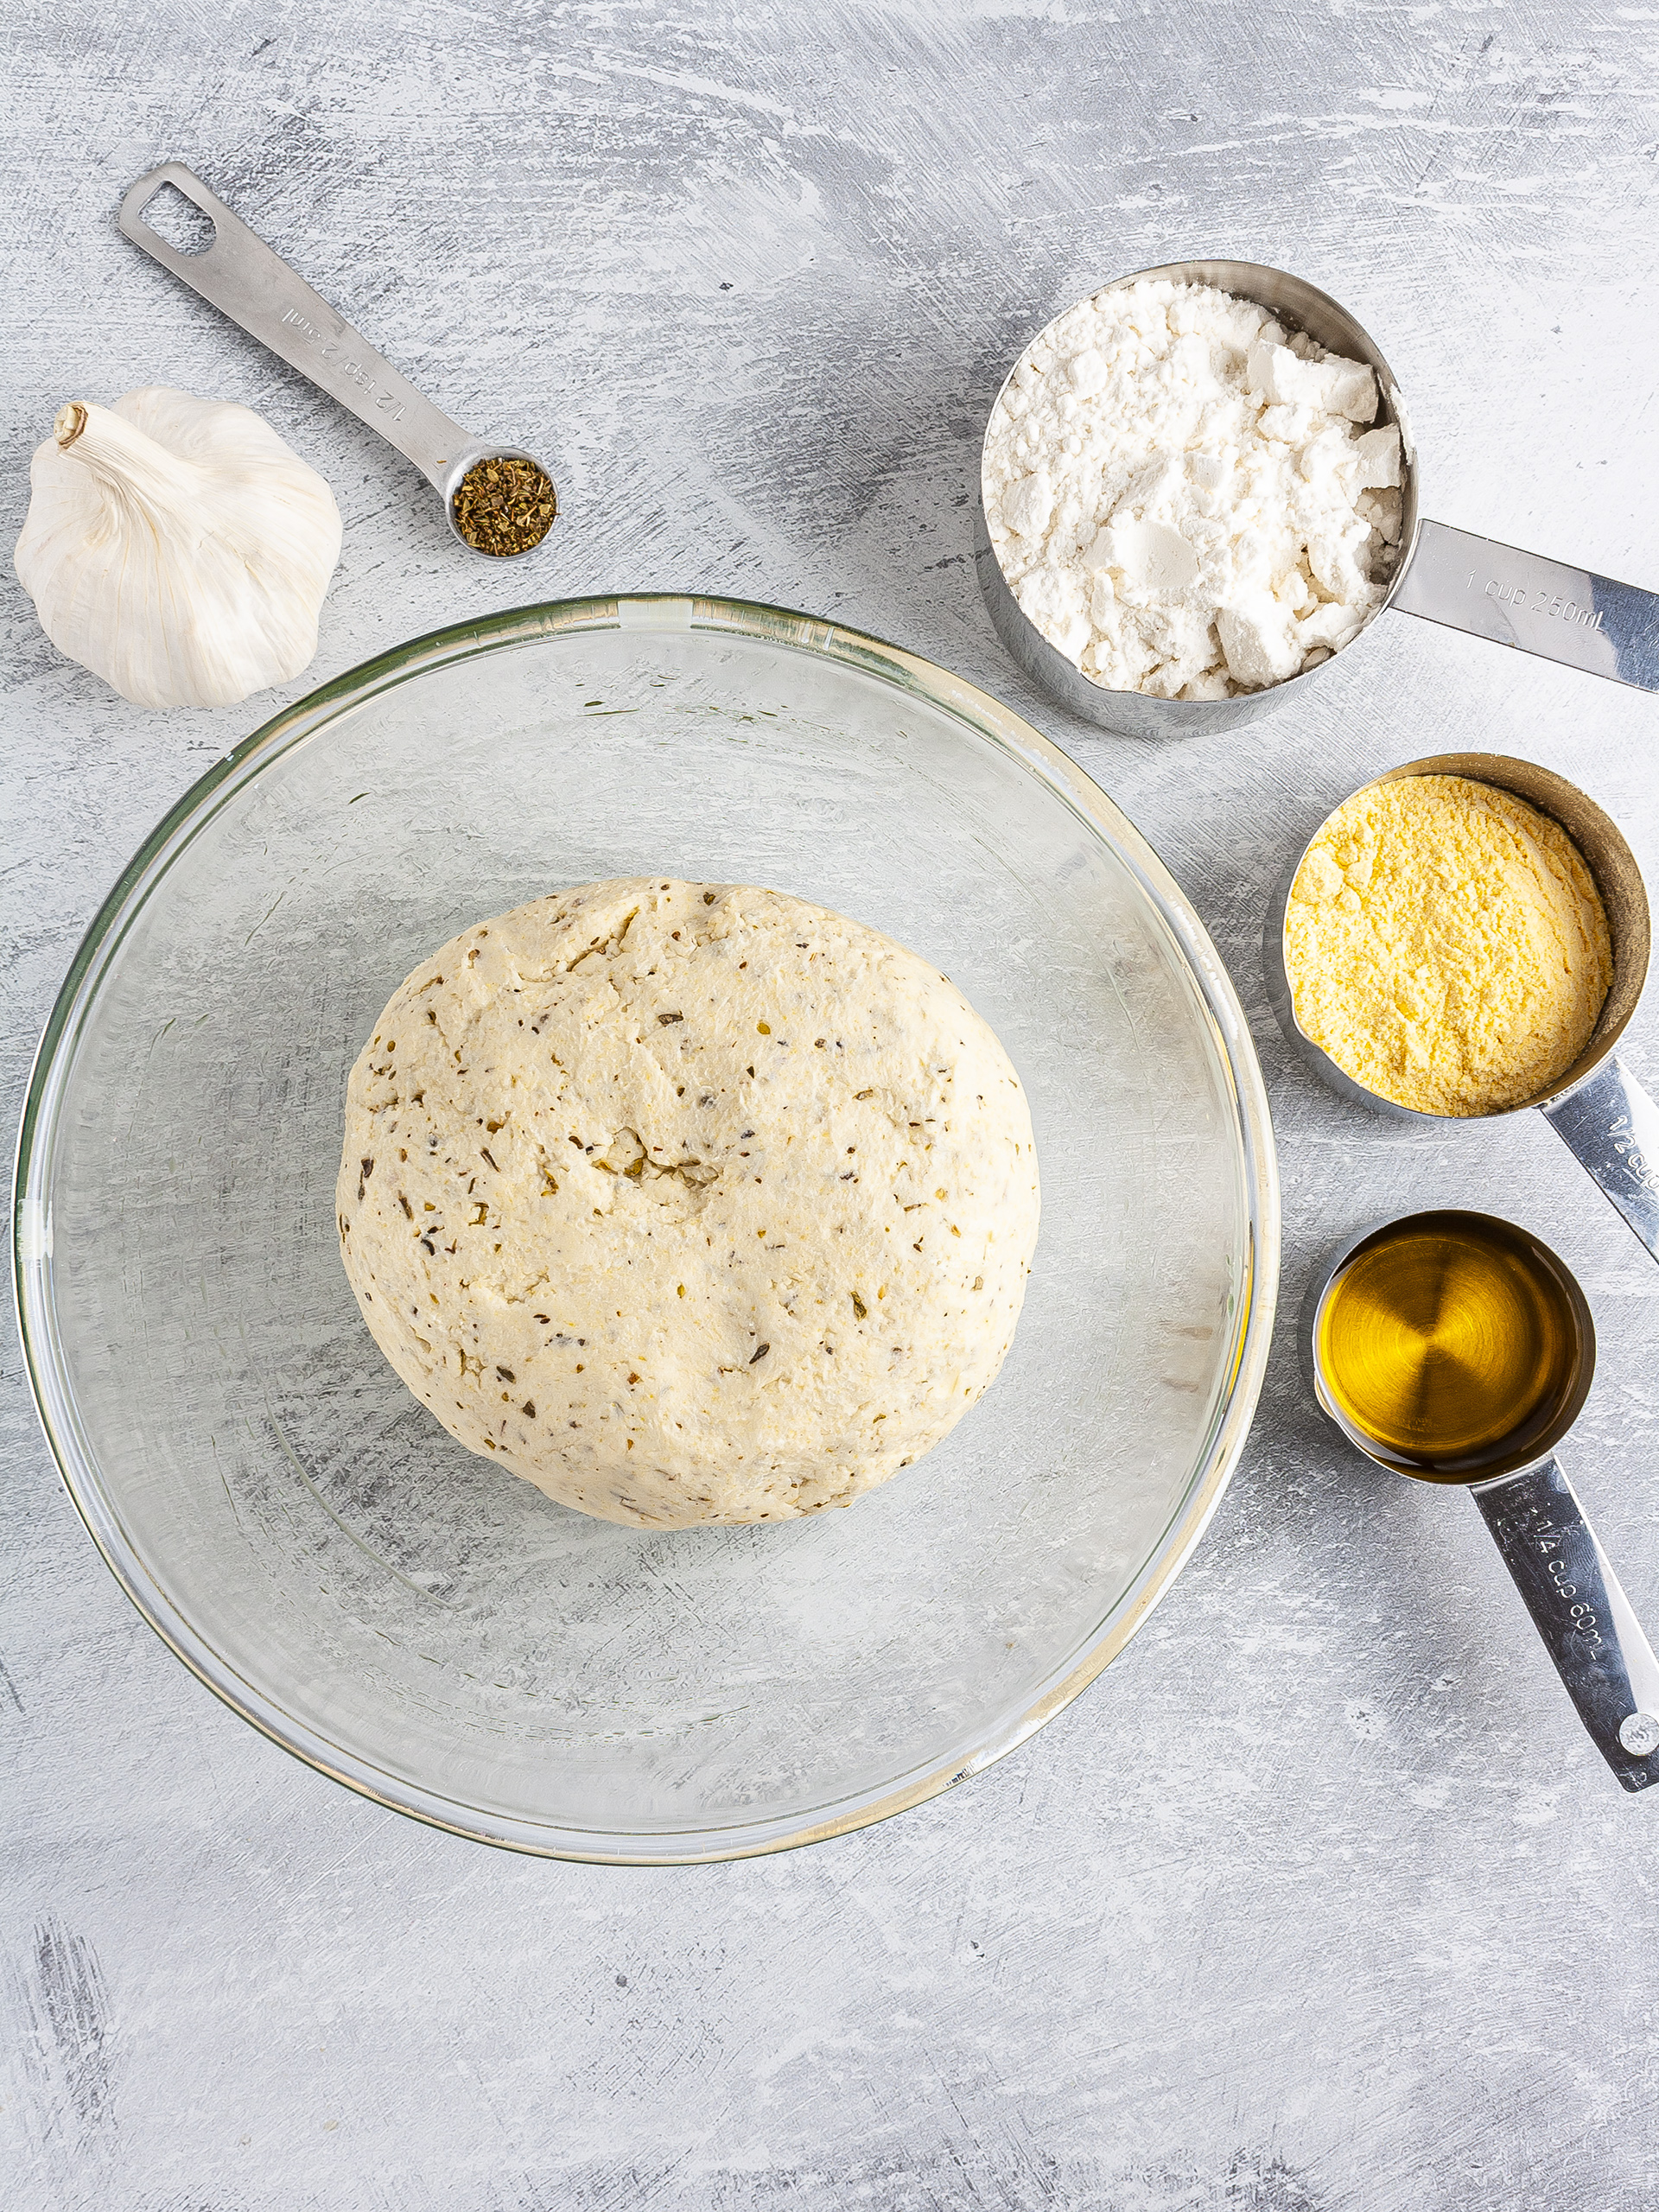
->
11, 593, 1279, 1867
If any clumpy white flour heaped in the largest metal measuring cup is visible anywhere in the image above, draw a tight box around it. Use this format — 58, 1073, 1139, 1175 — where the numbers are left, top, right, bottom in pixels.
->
982, 279, 1400, 699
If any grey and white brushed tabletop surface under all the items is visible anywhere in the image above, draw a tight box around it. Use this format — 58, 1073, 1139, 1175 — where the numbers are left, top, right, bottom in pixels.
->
0, 0, 1659, 2212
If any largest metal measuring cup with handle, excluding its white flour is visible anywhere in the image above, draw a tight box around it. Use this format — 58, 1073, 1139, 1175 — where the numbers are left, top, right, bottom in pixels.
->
973, 261, 1659, 736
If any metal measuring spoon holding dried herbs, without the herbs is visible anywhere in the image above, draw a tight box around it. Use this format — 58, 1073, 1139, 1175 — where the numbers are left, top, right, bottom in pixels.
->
119, 162, 557, 560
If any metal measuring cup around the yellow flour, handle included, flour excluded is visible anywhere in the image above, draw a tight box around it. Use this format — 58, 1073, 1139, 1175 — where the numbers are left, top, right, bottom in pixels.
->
1261, 752, 1659, 1259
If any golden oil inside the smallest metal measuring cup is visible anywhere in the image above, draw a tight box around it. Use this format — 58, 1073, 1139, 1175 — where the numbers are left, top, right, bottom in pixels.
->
1314, 1212, 1595, 1482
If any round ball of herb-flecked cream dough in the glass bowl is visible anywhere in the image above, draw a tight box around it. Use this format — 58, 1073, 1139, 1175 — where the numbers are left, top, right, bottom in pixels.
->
339, 878, 1038, 1529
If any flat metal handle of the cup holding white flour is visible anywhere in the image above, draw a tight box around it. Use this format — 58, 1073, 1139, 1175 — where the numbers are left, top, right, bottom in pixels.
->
1394, 522, 1659, 690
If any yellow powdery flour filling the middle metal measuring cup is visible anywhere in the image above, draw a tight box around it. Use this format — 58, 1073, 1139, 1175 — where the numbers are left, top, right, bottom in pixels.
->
1285, 777, 1612, 1115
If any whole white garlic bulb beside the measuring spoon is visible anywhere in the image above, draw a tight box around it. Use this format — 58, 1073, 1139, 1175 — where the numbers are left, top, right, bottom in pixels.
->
13, 385, 340, 706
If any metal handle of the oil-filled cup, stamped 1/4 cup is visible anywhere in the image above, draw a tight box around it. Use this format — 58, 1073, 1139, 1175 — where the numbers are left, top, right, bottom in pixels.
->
1473, 1458, 1659, 1789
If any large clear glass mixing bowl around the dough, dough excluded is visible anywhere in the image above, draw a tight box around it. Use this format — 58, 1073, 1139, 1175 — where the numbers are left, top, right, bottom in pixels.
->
16, 600, 1279, 1863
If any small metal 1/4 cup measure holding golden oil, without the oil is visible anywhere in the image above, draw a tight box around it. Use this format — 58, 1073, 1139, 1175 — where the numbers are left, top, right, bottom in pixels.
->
1300, 1210, 1659, 1789
